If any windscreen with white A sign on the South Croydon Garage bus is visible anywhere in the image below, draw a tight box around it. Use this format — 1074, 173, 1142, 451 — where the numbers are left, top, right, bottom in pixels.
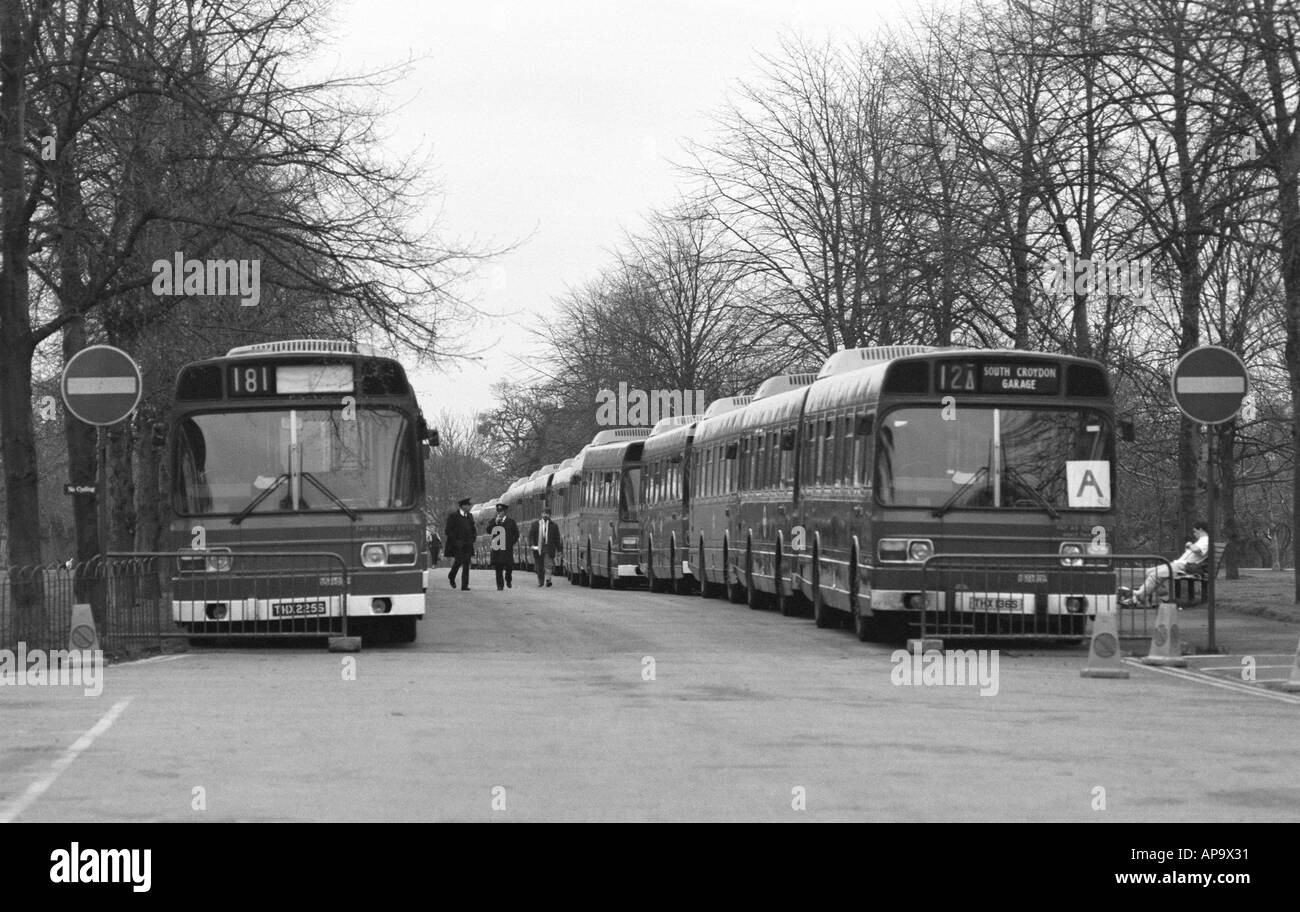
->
875, 405, 1114, 513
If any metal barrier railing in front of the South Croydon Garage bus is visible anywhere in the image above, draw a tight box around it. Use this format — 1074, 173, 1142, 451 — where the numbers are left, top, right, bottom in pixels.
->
915, 553, 1171, 640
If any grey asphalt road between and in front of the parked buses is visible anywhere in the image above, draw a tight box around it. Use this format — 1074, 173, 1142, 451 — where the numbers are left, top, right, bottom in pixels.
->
0, 570, 1300, 821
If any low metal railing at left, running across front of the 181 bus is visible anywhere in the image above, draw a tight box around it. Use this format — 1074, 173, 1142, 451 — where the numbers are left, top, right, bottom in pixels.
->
0, 551, 351, 653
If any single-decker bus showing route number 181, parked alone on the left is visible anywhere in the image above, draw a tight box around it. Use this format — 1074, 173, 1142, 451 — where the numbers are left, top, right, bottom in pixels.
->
168, 339, 437, 642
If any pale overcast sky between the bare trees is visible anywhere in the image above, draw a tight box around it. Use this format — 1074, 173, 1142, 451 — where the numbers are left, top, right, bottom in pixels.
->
313, 0, 914, 416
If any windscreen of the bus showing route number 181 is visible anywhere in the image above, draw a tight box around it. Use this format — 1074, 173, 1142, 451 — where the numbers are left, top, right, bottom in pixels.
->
174, 407, 417, 516
